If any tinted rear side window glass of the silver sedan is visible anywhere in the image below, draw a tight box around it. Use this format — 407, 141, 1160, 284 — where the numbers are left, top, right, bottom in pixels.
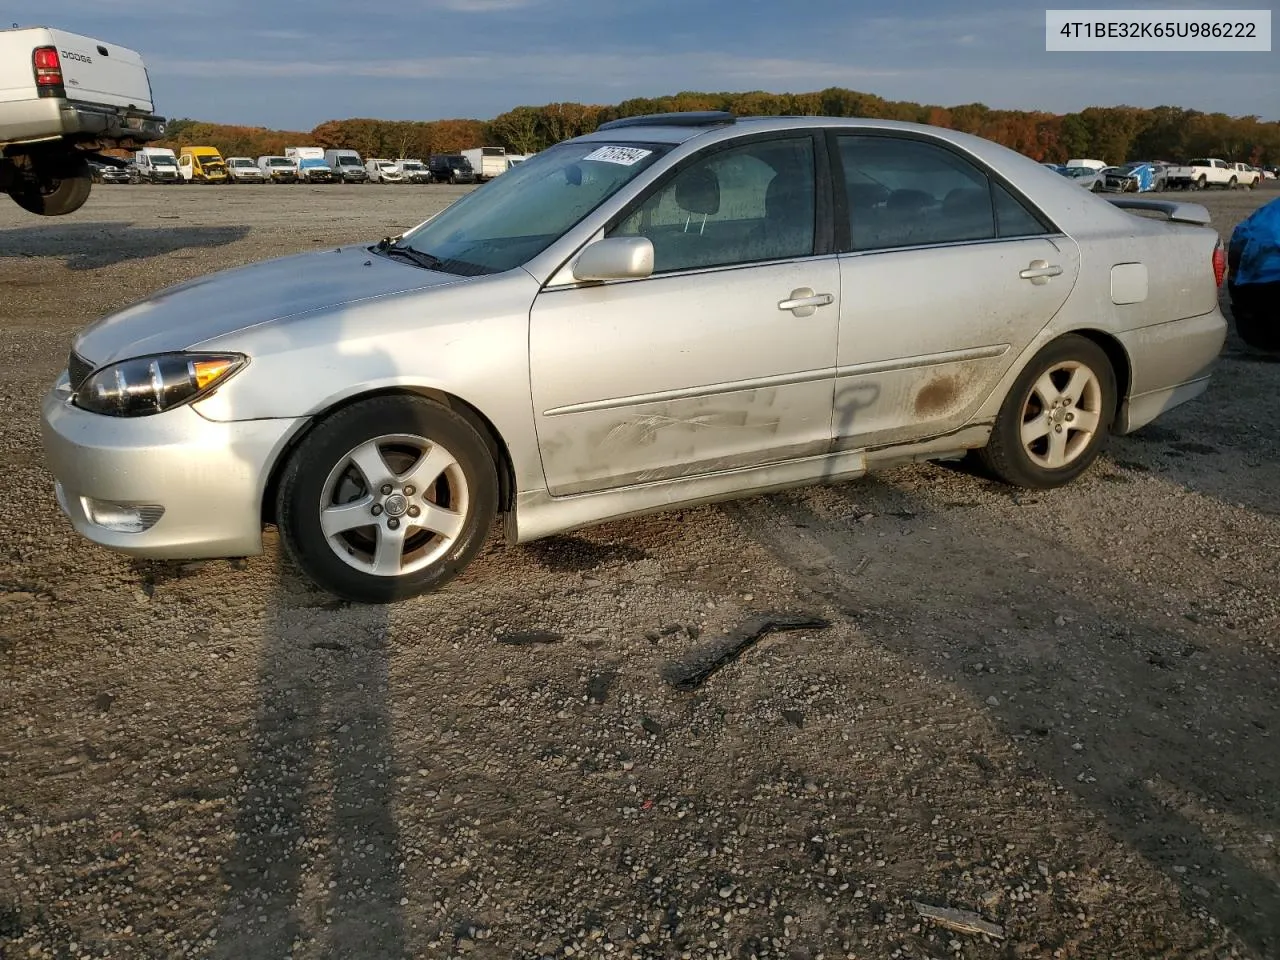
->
837, 136, 1046, 251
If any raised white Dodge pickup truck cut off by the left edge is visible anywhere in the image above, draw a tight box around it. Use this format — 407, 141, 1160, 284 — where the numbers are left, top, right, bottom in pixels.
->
0, 27, 165, 216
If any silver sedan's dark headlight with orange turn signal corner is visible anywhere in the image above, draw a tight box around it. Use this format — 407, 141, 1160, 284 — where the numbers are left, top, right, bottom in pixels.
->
73, 353, 248, 417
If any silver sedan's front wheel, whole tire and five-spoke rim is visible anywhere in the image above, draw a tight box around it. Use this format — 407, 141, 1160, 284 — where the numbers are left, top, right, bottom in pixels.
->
275, 397, 498, 603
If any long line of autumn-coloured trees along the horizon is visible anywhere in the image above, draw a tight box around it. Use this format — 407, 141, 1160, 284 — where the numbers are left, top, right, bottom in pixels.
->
149, 87, 1280, 164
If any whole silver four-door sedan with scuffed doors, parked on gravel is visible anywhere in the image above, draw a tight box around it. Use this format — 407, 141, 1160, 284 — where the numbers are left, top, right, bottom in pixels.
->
44, 114, 1226, 602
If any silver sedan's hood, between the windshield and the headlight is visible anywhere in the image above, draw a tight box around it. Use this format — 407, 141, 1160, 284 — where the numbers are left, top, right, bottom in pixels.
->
74, 246, 458, 366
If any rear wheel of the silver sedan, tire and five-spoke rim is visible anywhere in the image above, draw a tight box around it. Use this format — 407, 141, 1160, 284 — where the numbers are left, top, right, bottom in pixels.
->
979, 334, 1116, 489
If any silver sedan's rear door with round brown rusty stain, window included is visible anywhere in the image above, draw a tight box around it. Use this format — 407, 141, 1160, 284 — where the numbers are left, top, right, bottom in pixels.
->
832, 133, 1080, 448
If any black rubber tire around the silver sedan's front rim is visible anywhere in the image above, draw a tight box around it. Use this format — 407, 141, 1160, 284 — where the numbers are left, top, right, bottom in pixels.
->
275, 397, 498, 603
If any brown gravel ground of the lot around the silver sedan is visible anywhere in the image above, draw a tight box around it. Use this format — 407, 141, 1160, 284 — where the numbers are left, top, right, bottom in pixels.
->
0, 184, 1280, 960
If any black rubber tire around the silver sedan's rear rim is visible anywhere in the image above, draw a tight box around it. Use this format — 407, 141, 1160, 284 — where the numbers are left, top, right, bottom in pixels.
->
978, 334, 1116, 490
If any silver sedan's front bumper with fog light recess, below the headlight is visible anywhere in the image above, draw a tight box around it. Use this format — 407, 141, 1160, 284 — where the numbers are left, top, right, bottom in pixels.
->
41, 374, 306, 559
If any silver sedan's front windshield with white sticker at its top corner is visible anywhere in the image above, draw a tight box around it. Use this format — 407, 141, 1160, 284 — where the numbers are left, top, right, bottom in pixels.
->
401, 142, 669, 275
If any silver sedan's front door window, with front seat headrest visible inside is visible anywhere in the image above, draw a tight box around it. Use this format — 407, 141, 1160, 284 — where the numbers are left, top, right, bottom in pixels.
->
606, 136, 817, 273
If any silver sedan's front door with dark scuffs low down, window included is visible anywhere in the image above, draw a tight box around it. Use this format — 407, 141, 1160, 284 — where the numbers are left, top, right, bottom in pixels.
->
530, 136, 840, 495
